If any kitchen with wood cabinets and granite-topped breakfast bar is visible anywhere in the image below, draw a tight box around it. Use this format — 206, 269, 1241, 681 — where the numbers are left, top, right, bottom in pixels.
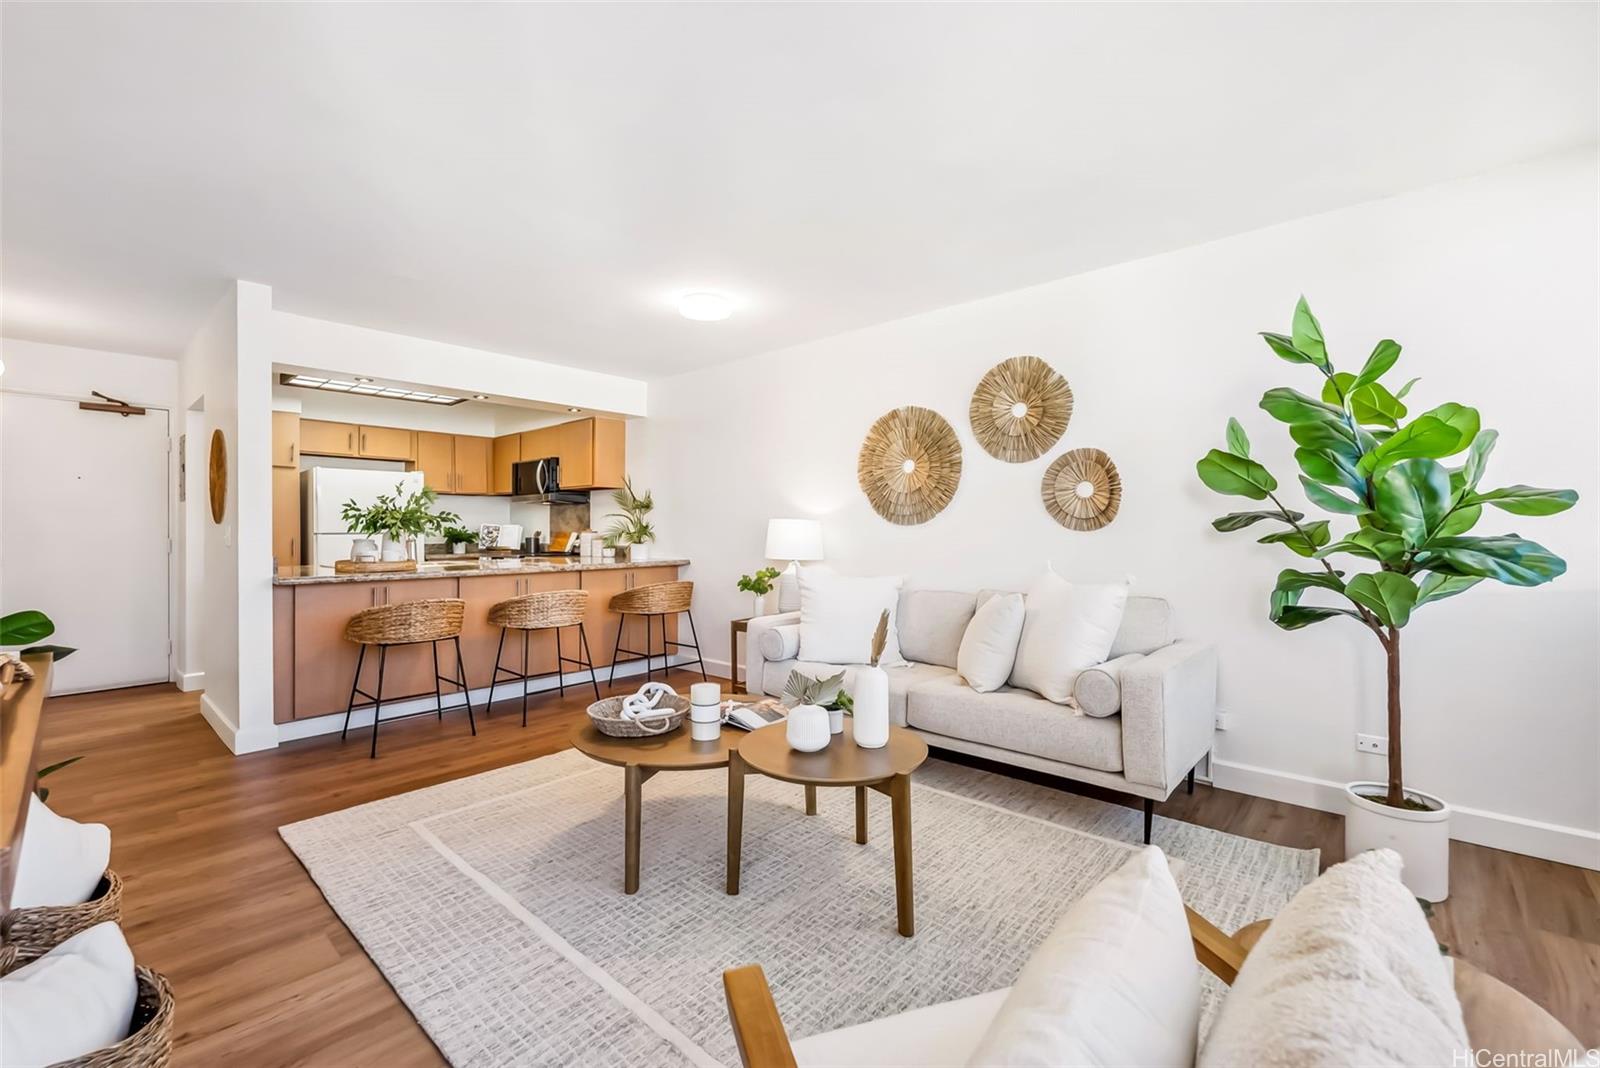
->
272, 371, 688, 740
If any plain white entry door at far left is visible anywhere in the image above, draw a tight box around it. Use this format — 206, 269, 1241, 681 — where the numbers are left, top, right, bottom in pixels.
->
0, 393, 171, 694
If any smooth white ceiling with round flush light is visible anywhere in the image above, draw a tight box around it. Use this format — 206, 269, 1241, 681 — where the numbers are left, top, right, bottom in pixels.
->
0, 3, 1597, 377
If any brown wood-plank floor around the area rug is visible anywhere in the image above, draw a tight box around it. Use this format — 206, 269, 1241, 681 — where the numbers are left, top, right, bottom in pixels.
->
31, 673, 1600, 1068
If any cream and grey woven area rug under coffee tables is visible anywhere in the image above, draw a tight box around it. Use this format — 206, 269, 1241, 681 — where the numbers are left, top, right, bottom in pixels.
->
280, 751, 1317, 1068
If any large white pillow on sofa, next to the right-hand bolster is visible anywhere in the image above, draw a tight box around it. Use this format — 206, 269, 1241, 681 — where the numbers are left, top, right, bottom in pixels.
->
1011, 568, 1128, 705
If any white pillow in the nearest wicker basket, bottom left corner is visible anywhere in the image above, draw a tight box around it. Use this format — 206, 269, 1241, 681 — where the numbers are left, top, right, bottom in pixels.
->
0, 921, 139, 1068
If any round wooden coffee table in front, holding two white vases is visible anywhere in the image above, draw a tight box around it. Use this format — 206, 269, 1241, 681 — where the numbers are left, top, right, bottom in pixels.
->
728, 716, 928, 938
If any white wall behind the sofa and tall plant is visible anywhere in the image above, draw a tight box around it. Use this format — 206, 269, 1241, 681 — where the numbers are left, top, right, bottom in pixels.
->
629, 152, 1600, 867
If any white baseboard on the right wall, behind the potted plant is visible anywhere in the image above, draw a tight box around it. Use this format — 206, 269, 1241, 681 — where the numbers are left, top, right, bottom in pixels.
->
1211, 759, 1600, 871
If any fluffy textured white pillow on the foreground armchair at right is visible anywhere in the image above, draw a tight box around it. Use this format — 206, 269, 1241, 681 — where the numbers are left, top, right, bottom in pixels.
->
1200, 849, 1469, 1068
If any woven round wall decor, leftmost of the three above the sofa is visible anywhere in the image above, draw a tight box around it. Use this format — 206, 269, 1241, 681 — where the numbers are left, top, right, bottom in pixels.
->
856, 404, 962, 526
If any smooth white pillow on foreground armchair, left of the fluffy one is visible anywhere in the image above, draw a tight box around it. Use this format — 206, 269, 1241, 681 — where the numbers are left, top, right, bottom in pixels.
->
966, 846, 1203, 1068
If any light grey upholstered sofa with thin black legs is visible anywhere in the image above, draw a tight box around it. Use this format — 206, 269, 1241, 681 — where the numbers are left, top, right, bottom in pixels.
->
746, 590, 1216, 841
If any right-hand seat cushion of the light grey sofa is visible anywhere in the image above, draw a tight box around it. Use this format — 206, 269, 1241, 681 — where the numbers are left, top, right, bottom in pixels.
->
891, 671, 1122, 772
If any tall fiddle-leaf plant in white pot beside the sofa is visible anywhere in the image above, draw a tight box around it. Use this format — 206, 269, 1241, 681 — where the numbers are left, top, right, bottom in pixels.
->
1197, 297, 1578, 902
